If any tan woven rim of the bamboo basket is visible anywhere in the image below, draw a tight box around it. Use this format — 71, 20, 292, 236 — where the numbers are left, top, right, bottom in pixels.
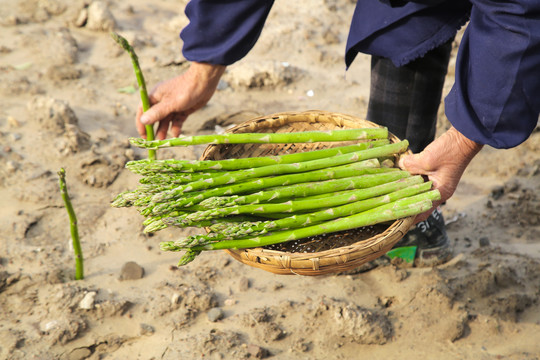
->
201, 110, 415, 275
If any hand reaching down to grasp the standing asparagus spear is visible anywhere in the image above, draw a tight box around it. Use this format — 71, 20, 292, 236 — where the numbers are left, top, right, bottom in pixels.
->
135, 62, 226, 140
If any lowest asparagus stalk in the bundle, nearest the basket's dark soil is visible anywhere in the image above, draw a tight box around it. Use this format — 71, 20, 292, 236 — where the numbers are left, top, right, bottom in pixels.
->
160, 190, 440, 265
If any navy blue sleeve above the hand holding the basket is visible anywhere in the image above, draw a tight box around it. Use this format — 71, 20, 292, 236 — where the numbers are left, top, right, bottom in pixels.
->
445, 0, 540, 148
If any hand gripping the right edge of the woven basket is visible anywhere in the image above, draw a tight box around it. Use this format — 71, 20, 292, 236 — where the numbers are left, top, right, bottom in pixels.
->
399, 127, 483, 222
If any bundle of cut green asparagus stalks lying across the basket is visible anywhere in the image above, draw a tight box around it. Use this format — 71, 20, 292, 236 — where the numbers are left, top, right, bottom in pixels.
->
113, 128, 440, 265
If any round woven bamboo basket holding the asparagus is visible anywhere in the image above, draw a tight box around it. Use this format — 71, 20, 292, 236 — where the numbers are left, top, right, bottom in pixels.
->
201, 111, 414, 276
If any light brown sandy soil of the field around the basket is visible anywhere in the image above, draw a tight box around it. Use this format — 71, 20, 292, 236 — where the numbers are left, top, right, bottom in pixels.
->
0, 0, 540, 360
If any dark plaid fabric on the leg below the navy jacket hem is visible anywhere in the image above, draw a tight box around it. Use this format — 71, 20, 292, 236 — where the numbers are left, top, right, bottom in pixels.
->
367, 39, 453, 153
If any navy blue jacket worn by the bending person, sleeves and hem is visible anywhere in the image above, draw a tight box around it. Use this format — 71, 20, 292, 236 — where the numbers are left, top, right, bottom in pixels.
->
181, 0, 540, 148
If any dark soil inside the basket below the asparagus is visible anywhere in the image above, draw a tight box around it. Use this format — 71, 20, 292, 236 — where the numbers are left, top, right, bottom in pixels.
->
264, 224, 389, 253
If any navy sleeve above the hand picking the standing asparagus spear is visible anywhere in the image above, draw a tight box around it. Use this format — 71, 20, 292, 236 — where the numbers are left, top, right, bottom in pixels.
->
180, 0, 273, 65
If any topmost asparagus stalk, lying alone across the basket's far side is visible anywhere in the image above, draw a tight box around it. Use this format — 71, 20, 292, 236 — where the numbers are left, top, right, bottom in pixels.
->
130, 128, 388, 149
